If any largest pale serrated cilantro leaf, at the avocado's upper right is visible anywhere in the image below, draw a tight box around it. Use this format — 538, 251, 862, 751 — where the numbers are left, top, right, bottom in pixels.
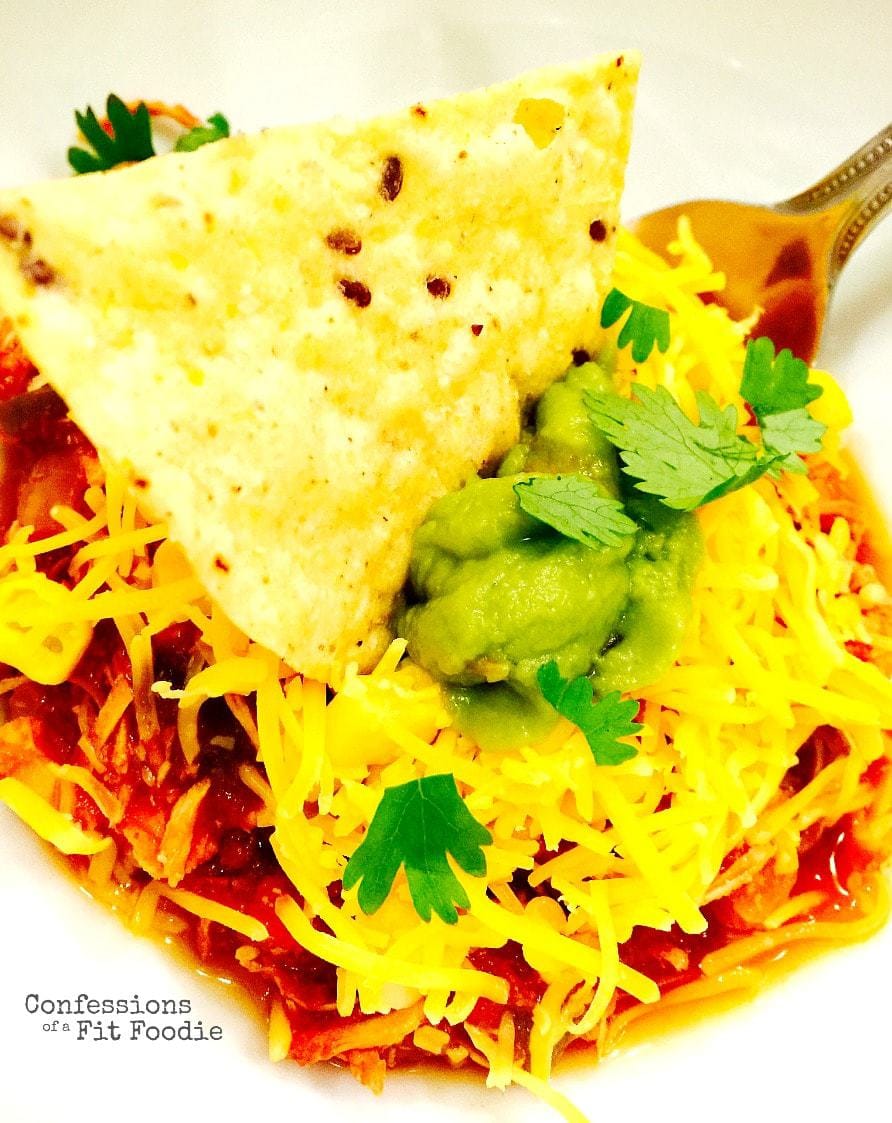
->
585, 385, 784, 511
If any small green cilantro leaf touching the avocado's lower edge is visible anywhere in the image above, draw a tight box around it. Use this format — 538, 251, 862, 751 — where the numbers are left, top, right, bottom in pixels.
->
536, 660, 644, 765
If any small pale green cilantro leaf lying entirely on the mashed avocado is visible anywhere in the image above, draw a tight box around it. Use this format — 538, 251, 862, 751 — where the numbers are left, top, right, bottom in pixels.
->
515, 475, 638, 549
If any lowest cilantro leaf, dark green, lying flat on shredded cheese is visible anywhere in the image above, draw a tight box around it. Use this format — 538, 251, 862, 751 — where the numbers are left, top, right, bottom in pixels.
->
344, 773, 492, 924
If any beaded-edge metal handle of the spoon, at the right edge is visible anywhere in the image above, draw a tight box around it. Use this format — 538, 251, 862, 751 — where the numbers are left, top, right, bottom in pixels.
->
774, 125, 892, 284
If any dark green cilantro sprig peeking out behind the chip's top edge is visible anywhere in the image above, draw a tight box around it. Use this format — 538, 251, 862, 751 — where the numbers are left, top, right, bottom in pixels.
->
69, 93, 229, 175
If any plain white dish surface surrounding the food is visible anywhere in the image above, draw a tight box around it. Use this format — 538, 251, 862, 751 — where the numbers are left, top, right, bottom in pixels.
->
0, 0, 892, 1123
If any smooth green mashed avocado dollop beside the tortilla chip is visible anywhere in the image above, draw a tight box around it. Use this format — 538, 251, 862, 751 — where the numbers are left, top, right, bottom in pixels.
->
398, 363, 701, 748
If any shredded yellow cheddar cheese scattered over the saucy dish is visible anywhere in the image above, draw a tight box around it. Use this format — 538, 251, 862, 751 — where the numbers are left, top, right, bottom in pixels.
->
0, 223, 892, 1123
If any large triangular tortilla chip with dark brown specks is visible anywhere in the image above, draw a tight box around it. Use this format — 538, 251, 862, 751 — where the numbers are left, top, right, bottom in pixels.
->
0, 55, 637, 681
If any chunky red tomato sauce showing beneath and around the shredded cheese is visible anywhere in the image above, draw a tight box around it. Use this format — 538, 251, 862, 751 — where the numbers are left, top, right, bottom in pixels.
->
0, 388, 889, 1066
